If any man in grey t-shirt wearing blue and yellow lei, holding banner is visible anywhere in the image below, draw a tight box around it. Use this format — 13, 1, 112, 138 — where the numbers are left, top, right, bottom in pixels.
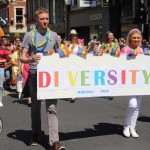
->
21, 8, 65, 150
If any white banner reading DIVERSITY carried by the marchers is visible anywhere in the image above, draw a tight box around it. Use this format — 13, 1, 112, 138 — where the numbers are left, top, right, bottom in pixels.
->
37, 54, 150, 99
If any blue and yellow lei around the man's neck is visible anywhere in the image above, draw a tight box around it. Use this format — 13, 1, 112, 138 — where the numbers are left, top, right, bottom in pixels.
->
32, 28, 50, 52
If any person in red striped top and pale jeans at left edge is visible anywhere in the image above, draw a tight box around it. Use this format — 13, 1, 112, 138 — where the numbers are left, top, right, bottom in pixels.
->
0, 43, 10, 107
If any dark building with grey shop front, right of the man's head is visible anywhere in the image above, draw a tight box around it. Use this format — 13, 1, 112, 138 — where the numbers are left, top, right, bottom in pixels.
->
66, 0, 150, 41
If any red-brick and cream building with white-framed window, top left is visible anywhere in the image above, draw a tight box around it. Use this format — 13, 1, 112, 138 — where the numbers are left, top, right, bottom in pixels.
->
0, 0, 27, 36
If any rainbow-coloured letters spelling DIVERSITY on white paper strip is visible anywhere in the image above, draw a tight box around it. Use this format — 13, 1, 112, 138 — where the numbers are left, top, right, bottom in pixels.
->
38, 68, 150, 90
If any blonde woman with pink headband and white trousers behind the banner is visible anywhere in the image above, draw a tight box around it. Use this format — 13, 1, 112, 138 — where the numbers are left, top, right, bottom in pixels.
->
122, 29, 143, 138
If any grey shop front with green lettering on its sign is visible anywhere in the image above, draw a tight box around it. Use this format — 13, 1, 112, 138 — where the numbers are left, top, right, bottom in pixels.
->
69, 6, 109, 43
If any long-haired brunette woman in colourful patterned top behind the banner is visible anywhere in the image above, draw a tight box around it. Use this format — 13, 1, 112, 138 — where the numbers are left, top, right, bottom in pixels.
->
100, 31, 120, 53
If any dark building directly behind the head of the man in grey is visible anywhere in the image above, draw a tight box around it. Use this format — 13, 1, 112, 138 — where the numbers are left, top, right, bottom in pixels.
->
27, 0, 65, 36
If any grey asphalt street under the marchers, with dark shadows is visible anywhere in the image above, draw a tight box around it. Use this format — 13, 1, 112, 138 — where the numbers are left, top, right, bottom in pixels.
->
0, 90, 150, 150
